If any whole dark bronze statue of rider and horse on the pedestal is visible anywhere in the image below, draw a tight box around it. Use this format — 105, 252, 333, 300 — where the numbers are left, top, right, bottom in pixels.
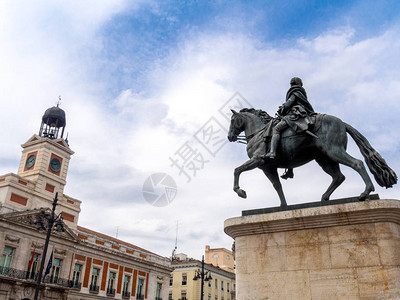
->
228, 77, 397, 207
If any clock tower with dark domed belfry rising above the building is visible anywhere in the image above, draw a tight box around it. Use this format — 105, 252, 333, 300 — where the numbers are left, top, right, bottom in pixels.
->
0, 105, 81, 229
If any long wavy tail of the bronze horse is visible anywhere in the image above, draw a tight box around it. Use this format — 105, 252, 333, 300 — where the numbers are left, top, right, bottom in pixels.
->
345, 123, 397, 188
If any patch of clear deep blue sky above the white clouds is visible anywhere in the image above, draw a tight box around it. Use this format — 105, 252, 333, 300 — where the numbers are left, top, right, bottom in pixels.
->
90, 1, 400, 93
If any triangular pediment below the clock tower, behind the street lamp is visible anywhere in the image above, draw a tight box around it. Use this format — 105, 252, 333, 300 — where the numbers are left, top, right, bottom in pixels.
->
0, 208, 80, 242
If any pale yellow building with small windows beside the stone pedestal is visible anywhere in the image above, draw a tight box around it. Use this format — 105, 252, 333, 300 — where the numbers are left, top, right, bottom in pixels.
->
168, 259, 235, 300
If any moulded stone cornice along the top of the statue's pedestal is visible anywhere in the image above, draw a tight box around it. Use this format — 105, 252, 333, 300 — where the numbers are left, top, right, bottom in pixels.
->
224, 199, 400, 239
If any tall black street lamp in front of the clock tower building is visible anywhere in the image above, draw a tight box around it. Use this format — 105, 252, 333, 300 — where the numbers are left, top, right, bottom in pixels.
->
33, 192, 65, 300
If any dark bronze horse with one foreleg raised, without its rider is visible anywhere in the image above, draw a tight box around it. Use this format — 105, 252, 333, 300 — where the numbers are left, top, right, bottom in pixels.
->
228, 108, 397, 206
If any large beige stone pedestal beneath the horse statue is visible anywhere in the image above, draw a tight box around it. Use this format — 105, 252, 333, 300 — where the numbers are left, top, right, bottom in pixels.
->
224, 199, 400, 300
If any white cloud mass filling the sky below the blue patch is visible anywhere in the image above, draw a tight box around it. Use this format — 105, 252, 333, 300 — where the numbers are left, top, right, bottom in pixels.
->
0, 1, 400, 257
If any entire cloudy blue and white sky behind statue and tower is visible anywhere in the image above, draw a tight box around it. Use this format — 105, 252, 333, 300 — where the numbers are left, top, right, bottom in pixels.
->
0, 0, 400, 258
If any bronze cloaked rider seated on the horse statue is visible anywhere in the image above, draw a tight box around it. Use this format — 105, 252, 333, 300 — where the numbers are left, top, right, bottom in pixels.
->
265, 77, 315, 179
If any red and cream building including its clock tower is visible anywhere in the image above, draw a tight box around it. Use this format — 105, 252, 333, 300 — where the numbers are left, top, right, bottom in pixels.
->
0, 106, 172, 300
